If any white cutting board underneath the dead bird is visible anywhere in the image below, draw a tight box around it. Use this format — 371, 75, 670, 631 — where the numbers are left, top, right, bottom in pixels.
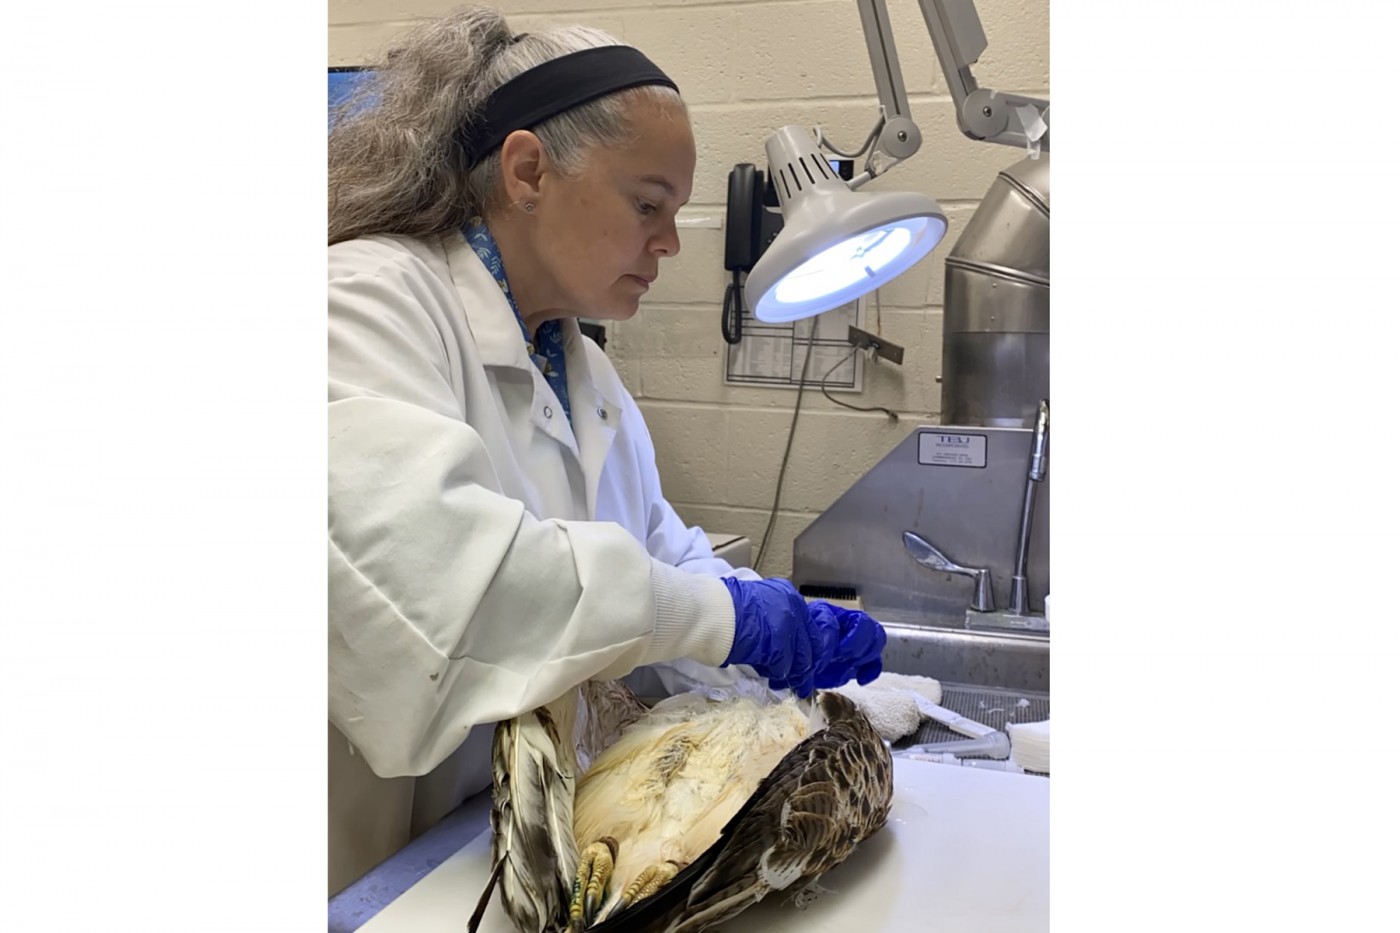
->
360, 758, 1050, 933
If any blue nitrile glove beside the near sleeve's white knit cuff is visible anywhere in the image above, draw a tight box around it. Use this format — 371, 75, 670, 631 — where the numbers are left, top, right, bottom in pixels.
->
720, 577, 817, 696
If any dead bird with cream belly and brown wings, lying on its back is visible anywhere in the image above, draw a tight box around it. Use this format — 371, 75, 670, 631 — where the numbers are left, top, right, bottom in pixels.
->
469, 681, 893, 933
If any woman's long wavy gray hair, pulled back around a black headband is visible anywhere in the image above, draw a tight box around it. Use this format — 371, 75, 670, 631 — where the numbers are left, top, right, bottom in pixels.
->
328, 7, 685, 244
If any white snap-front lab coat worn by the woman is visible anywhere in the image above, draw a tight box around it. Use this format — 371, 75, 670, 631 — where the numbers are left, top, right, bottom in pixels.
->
328, 234, 757, 891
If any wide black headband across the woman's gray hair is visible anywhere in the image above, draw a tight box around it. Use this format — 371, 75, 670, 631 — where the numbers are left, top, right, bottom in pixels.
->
458, 45, 680, 167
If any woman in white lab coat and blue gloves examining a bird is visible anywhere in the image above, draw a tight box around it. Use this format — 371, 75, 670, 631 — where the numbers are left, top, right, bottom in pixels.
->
329, 8, 885, 896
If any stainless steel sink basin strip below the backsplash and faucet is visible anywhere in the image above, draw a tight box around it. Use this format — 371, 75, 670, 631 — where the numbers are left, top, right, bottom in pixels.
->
882, 619, 1050, 693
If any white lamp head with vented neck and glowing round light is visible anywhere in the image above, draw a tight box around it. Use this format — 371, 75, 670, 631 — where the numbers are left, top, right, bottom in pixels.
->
743, 126, 948, 322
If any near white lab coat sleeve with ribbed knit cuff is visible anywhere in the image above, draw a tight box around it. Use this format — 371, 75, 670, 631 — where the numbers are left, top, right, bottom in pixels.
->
328, 243, 734, 778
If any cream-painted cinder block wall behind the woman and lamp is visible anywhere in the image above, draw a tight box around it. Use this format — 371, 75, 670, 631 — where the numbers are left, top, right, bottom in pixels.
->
329, 0, 1050, 576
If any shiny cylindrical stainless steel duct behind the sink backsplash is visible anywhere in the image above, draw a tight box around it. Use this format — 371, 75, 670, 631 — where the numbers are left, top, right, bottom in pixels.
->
942, 151, 1050, 427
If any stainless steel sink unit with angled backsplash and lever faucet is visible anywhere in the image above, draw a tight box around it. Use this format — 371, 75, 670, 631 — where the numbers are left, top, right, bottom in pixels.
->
792, 413, 1050, 691
